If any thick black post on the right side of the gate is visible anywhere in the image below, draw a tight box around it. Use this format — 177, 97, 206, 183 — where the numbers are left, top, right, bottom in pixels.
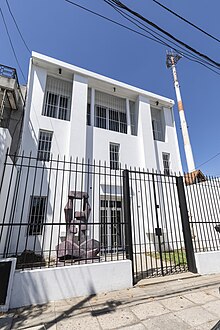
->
176, 176, 197, 273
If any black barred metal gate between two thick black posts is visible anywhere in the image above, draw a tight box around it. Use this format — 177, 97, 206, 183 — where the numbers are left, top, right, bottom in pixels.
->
124, 171, 195, 281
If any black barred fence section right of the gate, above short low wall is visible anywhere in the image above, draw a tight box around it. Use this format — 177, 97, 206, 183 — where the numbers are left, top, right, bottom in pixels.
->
185, 174, 220, 252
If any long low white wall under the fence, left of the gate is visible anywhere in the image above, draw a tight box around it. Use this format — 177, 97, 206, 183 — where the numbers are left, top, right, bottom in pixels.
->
10, 260, 132, 308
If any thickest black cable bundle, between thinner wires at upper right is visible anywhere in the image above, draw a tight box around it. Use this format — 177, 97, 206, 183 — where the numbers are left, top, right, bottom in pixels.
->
104, 0, 220, 68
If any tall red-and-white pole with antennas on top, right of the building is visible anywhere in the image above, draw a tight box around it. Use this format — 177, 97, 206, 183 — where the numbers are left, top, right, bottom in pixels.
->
166, 52, 195, 173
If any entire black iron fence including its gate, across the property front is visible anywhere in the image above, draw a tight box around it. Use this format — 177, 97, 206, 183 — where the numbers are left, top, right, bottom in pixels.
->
0, 154, 220, 280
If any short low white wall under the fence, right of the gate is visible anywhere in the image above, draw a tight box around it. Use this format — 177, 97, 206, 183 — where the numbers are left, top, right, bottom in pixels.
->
195, 251, 220, 275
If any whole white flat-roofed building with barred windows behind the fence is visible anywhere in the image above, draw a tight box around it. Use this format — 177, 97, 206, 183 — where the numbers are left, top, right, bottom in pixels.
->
0, 52, 182, 255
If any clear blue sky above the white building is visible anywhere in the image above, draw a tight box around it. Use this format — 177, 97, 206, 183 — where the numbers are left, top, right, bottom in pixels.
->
0, 0, 220, 176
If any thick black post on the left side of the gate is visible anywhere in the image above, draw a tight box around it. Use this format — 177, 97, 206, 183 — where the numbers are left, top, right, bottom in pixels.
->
123, 170, 134, 284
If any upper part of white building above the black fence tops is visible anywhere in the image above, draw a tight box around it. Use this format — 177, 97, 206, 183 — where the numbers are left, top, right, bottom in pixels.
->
21, 52, 182, 172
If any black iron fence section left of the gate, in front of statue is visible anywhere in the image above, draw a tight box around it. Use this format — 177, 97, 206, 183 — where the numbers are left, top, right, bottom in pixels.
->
0, 155, 127, 268
